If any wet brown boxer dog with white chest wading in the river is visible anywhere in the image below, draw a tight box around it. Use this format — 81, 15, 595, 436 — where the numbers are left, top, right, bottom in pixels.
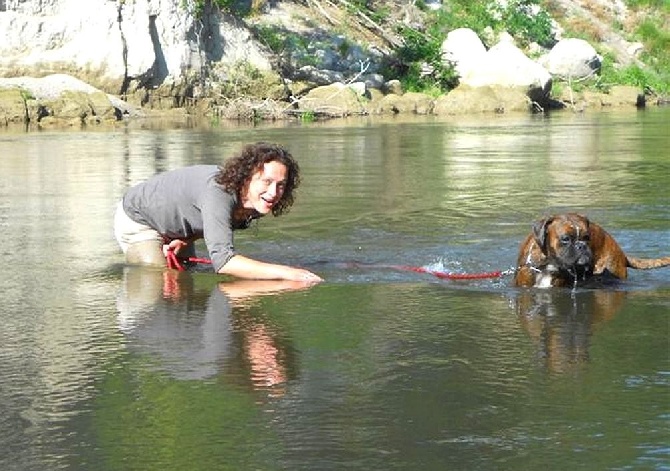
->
514, 213, 670, 288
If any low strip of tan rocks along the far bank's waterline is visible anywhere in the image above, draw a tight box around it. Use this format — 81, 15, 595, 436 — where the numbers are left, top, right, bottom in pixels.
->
0, 74, 665, 129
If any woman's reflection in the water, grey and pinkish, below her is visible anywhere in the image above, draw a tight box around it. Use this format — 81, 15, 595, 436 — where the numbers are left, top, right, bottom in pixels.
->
117, 267, 316, 395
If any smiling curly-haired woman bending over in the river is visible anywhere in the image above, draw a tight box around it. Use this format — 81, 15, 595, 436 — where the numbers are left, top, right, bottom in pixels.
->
114, 142, 322, 282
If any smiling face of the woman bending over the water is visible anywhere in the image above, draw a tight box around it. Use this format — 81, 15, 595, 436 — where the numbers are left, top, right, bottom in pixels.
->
242, 161, 288, 215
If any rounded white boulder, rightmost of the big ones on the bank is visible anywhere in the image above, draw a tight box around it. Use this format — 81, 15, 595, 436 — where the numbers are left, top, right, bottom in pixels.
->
538, 38, 602, 81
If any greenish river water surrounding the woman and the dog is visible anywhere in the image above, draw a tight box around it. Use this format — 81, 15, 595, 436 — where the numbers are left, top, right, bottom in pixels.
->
0, 108, 670, 471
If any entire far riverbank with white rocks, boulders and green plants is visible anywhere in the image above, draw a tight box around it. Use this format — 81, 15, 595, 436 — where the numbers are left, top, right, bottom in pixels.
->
0, 0, 667, 127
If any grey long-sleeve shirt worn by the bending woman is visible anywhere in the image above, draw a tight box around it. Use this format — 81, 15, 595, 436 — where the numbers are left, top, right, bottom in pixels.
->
123, 165, 250, 272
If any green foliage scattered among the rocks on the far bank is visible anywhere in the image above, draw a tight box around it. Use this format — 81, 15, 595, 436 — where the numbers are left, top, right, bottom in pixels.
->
197, 0, 670, 100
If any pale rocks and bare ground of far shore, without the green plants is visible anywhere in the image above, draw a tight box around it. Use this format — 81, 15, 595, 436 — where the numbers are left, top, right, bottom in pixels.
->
0, 0, 662, 127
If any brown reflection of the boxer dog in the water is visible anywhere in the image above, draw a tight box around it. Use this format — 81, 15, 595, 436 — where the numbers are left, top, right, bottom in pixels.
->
513, 289, 627, 373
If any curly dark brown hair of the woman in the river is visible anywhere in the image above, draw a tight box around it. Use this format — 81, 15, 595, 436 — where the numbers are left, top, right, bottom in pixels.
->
215, 142, 300, 216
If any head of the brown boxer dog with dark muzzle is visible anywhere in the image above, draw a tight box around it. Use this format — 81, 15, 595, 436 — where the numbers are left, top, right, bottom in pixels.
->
533, 213, 593, 275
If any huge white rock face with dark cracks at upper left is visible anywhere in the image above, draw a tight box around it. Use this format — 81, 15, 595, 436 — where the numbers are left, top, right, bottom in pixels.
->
0, 0, 271, 94
